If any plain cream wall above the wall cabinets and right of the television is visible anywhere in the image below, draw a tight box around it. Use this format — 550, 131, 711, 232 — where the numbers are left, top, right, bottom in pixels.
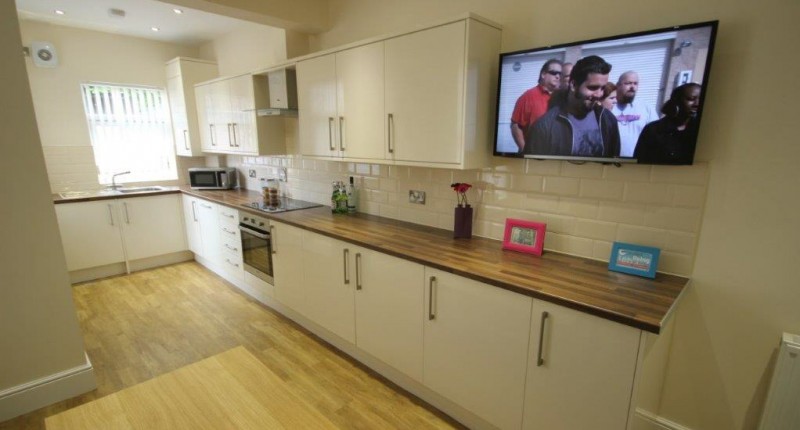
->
304, 0, 800, 430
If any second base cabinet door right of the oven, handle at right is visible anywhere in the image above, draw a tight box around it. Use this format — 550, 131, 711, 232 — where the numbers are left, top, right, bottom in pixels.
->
303, 231, 356, 343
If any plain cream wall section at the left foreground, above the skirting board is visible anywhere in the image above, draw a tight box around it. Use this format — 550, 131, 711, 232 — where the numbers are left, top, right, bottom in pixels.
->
0, 2, 93, 421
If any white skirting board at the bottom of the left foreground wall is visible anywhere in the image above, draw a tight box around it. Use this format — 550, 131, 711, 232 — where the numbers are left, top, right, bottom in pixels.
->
0, 355, 97, 422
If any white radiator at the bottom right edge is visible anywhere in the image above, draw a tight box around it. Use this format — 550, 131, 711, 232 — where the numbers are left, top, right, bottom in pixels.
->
760, 333, 800, 430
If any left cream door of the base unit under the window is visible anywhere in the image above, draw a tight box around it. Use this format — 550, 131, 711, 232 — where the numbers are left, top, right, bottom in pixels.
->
55, 200, 125, 271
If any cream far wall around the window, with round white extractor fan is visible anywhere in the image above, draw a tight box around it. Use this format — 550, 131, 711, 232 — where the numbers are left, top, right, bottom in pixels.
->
20, 20, 209, 192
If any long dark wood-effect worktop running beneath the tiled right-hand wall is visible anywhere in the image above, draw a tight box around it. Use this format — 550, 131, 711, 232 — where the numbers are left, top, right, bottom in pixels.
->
186, 187, 689, 333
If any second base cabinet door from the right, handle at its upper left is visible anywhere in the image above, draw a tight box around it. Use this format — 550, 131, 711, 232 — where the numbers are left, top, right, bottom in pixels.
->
423, 267, 532, 429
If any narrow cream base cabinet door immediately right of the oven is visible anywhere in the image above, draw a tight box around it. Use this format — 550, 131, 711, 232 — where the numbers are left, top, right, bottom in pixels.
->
270, 221, 304, 314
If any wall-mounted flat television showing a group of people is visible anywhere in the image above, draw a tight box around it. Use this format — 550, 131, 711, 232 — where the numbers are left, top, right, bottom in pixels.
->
494, 21, 718, 164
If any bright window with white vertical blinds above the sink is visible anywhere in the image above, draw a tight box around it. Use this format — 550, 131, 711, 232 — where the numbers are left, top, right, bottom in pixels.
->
81, 83, 178, 184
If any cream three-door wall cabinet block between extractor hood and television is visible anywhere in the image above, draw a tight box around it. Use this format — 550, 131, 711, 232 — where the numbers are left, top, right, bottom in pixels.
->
297, 16, 500, 169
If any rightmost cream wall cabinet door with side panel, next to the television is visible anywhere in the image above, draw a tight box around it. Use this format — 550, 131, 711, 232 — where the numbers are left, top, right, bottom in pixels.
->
385, 19, 500, 169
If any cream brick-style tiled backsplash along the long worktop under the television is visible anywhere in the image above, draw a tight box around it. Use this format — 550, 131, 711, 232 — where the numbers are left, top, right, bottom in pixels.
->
228, 157, 708, 275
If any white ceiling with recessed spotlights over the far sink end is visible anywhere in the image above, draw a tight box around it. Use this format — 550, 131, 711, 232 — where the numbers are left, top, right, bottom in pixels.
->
16, 0, 272, 45
